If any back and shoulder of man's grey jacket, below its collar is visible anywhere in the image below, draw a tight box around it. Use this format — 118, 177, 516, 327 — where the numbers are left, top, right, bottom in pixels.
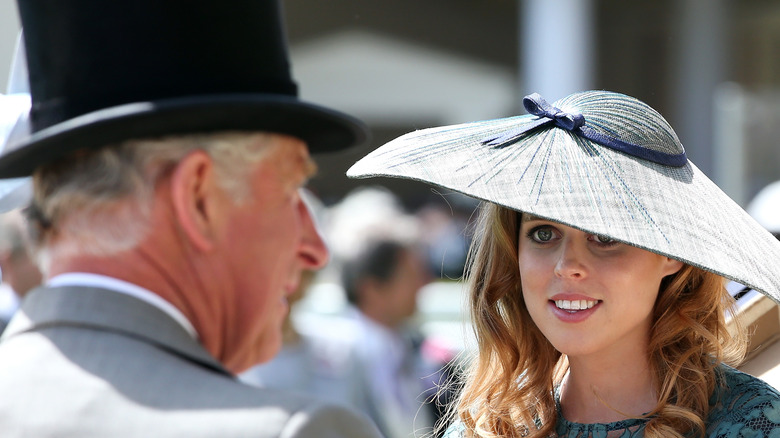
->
0, 327, 378, 438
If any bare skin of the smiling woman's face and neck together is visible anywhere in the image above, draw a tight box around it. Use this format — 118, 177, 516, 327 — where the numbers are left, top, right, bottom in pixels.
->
518, 214, 682, 422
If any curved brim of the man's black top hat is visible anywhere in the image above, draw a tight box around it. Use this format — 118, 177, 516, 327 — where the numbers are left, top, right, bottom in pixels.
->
0, 94, 369, 178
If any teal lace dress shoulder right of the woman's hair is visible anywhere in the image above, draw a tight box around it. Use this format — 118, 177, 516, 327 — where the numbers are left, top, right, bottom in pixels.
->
707, 366, 780, 438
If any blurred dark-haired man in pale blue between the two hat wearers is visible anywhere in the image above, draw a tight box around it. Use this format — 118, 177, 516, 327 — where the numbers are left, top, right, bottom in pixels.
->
342, 238, 444, 438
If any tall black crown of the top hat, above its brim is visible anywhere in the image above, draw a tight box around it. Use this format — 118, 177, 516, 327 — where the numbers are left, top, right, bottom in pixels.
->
18, 0, 297, 131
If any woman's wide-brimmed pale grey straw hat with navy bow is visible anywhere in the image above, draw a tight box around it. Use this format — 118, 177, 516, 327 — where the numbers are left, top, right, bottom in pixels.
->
347, 91, 780, 303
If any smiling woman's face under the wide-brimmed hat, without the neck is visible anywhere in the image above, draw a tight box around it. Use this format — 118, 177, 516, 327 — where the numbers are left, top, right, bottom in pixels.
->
518, 214, 682, 359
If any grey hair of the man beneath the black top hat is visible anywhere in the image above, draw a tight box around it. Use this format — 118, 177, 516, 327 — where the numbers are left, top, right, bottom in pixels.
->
28, 132, 272, 265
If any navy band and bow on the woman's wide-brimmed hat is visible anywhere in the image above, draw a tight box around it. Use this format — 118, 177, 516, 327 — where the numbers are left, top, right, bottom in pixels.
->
482, 93, 688, 167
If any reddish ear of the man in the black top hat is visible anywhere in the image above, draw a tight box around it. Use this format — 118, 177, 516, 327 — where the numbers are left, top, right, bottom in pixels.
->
170, 150, 225, 251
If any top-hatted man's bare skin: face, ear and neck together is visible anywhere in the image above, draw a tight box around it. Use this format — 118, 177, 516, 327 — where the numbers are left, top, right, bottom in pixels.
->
50, 135, 328, 373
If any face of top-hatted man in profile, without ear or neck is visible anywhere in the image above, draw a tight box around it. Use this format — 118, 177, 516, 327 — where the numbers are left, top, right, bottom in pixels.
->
221, 135, 328, 372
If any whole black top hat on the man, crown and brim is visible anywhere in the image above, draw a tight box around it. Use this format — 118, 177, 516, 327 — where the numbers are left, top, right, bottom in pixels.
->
0, 0, 368, 178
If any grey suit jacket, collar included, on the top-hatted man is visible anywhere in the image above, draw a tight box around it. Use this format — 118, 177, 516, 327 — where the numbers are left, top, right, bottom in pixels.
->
0, 287, 379, 438
